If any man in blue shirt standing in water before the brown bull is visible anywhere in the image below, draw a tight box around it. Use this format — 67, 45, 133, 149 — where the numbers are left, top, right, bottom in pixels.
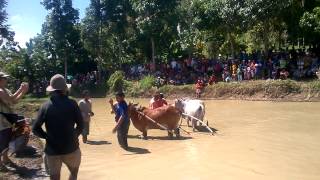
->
109, 92, 130, 150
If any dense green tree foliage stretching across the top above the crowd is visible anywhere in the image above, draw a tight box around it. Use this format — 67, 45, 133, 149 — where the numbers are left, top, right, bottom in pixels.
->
0, 0, 320, 95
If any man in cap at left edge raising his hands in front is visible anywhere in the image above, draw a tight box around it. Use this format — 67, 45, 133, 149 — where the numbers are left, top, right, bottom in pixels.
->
0, 72, 29, 171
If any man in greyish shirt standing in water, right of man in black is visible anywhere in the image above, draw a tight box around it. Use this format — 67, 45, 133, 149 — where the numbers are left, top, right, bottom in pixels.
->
79, 90, 94, 143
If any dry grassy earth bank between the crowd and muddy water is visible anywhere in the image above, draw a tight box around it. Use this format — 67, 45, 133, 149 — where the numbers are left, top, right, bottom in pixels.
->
125, 80, 320, 102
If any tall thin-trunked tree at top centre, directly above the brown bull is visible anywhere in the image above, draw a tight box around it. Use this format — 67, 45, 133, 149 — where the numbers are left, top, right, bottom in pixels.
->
130, 0, 179, 67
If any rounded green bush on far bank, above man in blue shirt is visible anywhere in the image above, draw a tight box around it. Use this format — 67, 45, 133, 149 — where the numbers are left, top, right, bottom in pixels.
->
107, 71, 126, 92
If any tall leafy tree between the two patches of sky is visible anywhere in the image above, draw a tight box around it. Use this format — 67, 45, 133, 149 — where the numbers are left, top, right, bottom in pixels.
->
42, 0, 88, 76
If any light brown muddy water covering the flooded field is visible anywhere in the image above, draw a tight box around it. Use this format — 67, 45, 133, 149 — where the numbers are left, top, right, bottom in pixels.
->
62, 99, 320, 180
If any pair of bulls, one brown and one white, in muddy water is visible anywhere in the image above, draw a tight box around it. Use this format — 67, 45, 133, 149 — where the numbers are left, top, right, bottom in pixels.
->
128, 99, 205, 139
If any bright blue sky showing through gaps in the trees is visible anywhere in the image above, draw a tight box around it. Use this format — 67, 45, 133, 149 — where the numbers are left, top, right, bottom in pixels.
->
7, 0, 90, 47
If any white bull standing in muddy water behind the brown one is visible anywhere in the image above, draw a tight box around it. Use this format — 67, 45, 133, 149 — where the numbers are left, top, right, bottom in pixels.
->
175, 99, 206, 131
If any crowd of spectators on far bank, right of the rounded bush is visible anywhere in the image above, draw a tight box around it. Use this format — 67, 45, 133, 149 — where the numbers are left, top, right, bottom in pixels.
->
123, 50, 320, 85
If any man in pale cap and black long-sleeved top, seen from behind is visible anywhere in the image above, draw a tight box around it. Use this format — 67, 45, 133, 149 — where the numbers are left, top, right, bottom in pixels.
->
33, 74, 83, 180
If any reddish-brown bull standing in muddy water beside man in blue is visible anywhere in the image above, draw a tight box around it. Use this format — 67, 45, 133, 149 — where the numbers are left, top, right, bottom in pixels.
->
128, 104, 181, 139
